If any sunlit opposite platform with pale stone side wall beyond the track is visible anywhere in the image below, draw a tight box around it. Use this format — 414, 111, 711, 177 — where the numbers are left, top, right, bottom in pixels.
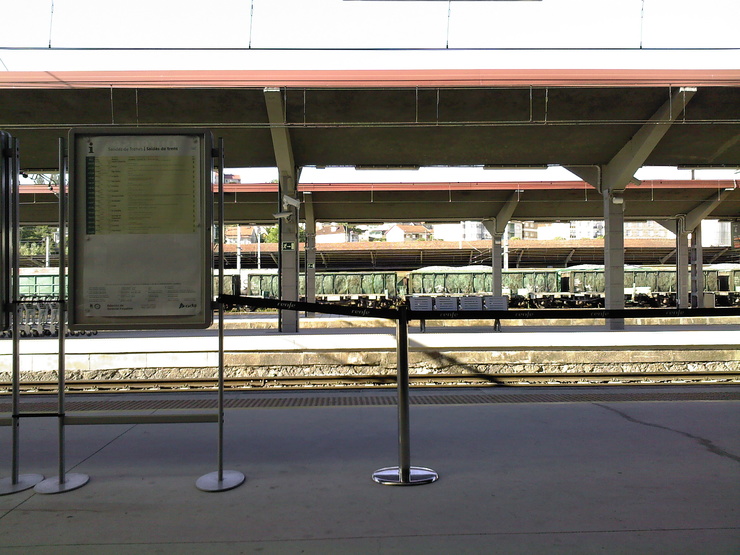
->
0, 318, 740, 384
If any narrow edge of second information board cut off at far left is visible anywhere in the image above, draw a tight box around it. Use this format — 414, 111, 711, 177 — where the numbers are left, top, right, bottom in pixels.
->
0, 131, 15, 331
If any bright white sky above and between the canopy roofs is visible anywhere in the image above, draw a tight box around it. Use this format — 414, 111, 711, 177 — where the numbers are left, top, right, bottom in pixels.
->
0, 0, 740, 181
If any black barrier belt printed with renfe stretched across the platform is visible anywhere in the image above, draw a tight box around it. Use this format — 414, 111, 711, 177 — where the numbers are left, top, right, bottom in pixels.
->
218, 295, 740, 320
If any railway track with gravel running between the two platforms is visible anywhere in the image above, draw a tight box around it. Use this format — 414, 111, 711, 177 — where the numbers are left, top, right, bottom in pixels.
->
0, 372, 740, 395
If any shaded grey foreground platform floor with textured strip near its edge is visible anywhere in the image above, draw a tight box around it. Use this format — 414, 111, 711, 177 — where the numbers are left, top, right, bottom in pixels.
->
0, 386, 740, 555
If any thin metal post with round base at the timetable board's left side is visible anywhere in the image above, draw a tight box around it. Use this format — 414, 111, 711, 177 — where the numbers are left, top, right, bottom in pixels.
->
35, 138, 90, 494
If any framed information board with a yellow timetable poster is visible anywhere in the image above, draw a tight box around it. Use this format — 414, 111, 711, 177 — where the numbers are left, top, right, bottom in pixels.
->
69, 129, 213, 329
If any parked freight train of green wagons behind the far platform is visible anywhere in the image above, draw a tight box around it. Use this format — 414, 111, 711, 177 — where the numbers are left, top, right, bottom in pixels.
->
11, 264, 740, 314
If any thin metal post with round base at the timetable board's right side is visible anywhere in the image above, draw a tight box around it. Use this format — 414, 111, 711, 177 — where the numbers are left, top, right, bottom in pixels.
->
195, 138, 246, 491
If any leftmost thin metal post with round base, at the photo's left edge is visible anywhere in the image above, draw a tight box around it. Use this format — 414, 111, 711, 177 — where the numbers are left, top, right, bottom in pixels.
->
0, 135, 44, 495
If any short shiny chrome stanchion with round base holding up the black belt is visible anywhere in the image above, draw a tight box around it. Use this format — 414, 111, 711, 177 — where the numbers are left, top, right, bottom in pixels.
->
373, 307, 439, 486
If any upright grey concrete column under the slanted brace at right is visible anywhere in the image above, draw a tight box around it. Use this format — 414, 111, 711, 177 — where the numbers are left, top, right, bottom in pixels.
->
604, 191, 624, 330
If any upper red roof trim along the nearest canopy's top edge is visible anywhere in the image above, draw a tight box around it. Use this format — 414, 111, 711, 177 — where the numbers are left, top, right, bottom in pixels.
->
0, 69, 740, 89
